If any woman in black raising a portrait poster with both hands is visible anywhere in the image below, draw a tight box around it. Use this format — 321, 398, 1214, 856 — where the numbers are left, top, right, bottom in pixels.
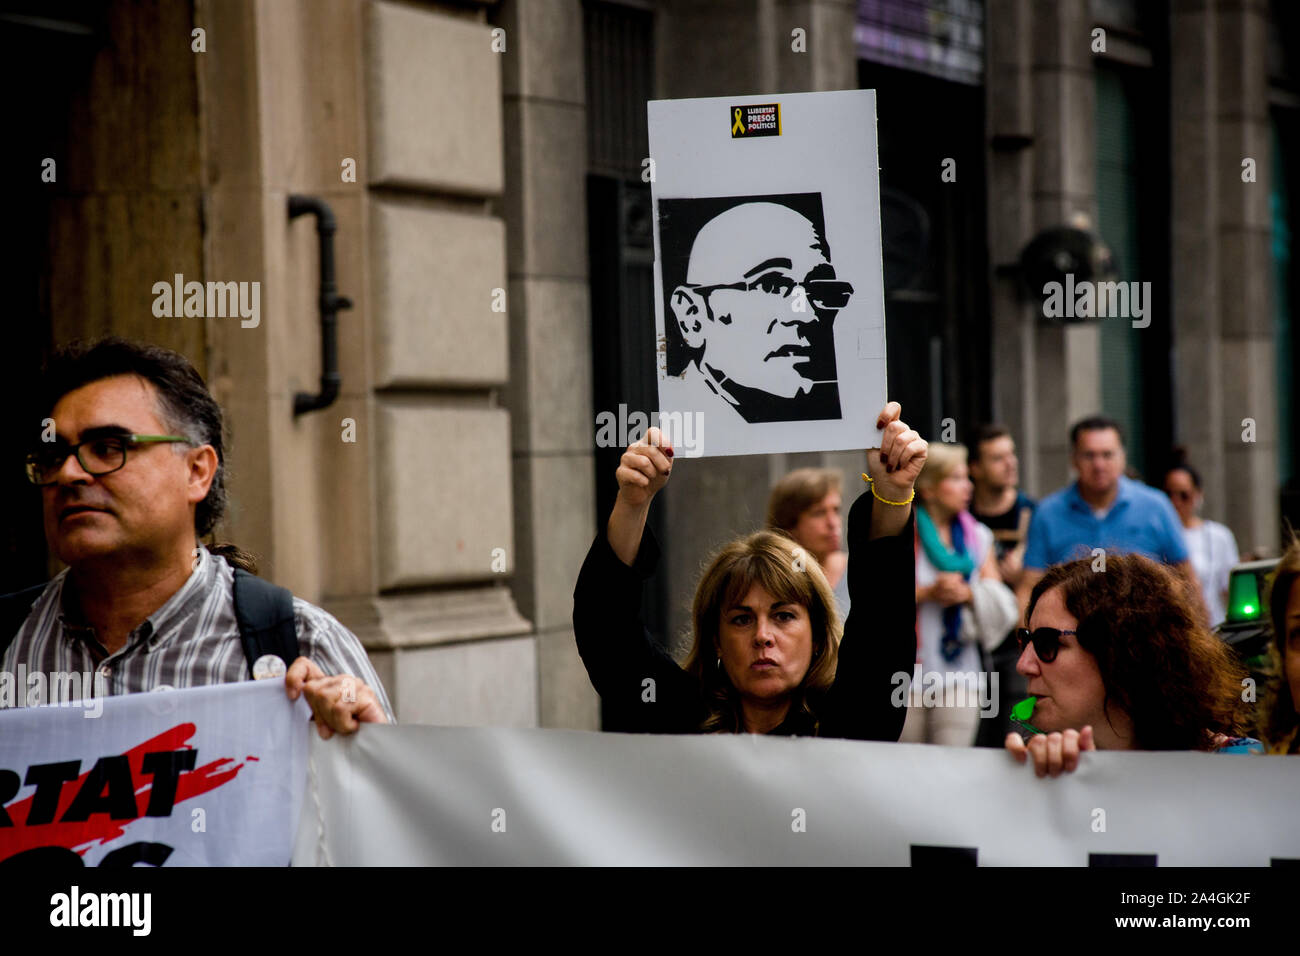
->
573, 402, 928, 740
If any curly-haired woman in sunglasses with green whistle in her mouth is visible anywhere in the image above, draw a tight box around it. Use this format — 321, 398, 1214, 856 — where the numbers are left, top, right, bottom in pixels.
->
1006, 554, 1264, 777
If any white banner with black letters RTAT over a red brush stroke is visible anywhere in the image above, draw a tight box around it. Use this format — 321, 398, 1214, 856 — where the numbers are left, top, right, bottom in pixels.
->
0, 680, 309, 866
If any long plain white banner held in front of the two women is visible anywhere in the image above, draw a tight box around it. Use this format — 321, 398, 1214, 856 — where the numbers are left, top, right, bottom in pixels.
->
294, 726, 1300, 866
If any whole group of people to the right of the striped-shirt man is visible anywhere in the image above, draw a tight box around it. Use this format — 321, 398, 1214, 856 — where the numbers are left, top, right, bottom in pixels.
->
573, 403, 1300, 775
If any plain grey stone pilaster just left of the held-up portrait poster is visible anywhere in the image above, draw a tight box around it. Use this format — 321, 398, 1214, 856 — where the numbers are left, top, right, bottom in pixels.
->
491, 0, 600, 730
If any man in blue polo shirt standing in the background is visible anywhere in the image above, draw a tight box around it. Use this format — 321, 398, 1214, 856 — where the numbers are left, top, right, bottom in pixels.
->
1017, 416, 1199, 607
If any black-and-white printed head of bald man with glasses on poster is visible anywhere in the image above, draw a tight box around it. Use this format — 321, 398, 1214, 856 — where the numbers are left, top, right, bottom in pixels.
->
666, 202, 853, 423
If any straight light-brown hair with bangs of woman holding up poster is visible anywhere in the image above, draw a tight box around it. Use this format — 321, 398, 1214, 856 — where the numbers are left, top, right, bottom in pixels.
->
683, 531, 844, 735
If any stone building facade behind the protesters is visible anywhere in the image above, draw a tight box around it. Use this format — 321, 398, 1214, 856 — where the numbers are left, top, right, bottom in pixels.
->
0, 0, 1283, 728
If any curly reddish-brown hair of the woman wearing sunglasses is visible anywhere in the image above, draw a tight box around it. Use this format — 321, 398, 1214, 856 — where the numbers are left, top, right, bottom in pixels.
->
1024, 554, 1247, 750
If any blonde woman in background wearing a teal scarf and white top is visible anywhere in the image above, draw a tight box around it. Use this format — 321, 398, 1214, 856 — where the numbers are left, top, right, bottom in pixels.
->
898, 442, 1005, 747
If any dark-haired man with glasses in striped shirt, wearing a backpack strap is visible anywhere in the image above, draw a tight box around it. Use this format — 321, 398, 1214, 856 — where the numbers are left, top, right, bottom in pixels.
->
0, 339, 393, 736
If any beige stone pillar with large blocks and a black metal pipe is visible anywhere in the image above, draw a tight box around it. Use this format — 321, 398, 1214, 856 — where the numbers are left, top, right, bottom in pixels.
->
200, 0, 537, 726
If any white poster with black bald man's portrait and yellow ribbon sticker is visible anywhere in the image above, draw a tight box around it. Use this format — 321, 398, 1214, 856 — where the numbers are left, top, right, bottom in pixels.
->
649, 90, 887, 457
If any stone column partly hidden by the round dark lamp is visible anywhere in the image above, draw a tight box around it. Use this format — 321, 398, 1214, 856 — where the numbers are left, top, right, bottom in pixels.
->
984, 0, 1101, 496
